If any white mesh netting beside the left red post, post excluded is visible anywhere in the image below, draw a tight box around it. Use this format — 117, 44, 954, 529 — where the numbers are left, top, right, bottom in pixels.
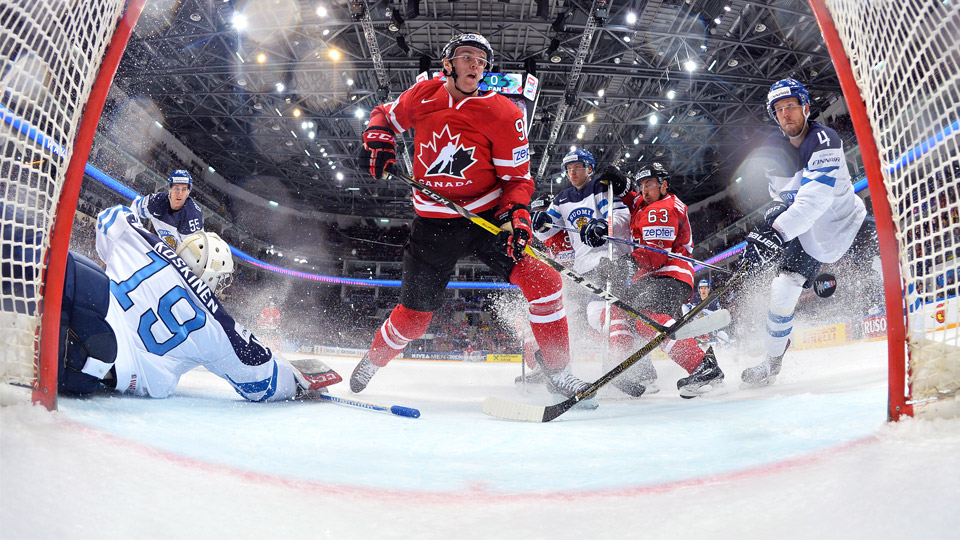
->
0, 0, 125, 400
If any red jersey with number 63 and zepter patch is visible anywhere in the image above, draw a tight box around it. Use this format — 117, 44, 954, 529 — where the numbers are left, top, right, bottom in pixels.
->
630, 194, 693, 290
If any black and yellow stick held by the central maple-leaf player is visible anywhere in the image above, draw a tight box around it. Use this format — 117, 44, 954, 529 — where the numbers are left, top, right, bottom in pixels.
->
386, 173, 730, 339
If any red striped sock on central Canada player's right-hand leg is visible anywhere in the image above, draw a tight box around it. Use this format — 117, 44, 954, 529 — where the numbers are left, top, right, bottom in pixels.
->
510, 257, 570, 370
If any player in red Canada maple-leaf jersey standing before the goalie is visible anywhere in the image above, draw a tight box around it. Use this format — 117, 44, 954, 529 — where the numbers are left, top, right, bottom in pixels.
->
350, 34, 590, 406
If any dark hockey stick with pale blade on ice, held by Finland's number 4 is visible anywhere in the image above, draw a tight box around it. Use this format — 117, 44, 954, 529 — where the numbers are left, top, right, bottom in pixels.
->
483, 265, 746, 422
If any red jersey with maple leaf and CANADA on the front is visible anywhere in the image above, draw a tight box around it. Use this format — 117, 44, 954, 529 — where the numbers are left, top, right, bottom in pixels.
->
370, 79, 534, 218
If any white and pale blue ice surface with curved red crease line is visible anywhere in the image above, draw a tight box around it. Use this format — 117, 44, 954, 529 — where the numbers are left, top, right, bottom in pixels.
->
0, 342, 960, 539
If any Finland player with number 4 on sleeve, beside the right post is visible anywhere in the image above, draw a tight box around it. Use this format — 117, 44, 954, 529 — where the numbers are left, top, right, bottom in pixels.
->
741, 79, 875, 385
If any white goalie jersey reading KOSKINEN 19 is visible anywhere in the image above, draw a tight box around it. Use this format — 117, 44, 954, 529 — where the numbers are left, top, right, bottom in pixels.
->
97, 205, 297, 401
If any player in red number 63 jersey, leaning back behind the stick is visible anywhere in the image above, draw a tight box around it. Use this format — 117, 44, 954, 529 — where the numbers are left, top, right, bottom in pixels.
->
598, 163, 723, 398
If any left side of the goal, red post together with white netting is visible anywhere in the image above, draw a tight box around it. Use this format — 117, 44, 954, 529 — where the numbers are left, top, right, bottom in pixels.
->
0, 0, 145, 409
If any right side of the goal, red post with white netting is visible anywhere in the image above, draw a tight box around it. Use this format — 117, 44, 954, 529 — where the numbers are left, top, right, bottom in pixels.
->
811, 0, 960, 419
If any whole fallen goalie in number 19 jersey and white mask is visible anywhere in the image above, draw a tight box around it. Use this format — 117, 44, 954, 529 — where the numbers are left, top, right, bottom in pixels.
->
59, 205, 341, 401
